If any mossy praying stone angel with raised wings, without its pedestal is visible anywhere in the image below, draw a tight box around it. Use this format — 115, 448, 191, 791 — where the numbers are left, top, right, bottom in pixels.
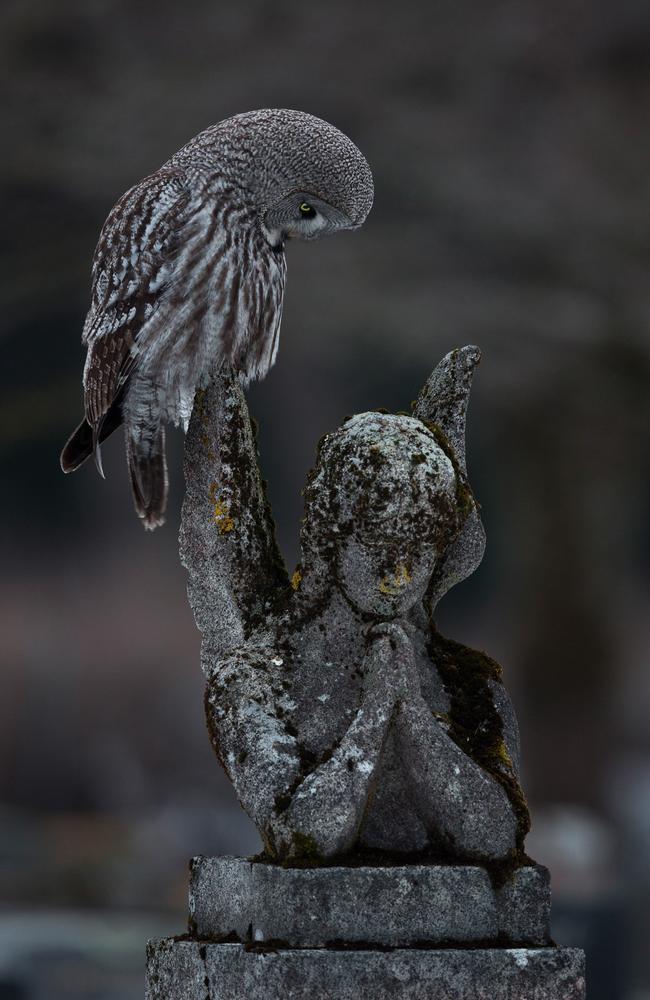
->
181, 347, 528, 864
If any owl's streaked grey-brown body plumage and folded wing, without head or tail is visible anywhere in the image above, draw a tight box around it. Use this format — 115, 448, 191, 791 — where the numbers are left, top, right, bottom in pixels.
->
84, 172, 286, 438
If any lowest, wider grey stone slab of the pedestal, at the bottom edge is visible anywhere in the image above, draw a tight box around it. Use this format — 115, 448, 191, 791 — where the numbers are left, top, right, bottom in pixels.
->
146, 939, 585, 1000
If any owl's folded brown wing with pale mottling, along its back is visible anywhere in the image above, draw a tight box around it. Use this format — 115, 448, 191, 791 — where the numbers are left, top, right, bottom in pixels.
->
82, 168, 193, 438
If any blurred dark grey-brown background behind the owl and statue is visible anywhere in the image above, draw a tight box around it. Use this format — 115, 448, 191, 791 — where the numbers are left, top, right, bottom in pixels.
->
0, 0, 650, 1000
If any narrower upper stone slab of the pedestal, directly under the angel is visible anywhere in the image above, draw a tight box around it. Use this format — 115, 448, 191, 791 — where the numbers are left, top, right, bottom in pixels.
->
190, 857, 550, 947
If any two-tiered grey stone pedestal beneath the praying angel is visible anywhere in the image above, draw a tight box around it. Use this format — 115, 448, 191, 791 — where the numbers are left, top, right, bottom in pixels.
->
147, 858, 585, 1000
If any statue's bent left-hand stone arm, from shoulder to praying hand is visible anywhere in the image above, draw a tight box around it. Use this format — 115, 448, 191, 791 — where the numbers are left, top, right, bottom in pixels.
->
206, 636, 399, 859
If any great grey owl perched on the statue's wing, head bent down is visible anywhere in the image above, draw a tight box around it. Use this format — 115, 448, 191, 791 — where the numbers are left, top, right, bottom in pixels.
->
61, 109, 373, 529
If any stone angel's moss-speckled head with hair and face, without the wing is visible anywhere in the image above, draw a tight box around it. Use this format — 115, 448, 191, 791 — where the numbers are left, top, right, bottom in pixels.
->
303, 413, 462, 620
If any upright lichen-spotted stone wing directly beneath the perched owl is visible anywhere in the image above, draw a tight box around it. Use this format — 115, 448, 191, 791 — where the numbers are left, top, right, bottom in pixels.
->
180, 367, 289, 672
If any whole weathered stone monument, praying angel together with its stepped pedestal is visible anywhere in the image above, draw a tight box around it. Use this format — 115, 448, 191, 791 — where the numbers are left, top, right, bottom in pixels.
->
152, 347, 585, 1000
